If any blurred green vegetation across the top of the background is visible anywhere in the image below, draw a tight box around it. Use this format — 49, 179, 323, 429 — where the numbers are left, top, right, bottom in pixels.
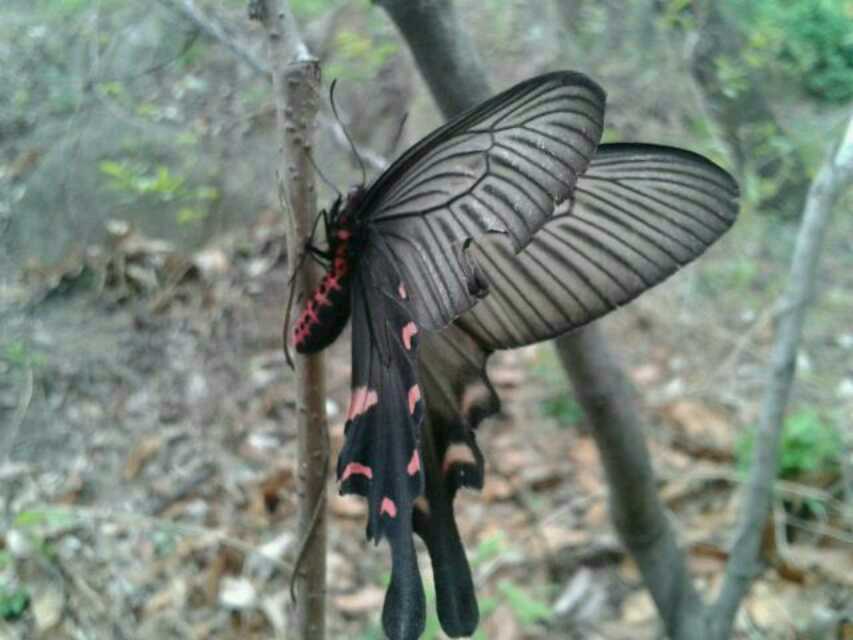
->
0, 0, 853, 266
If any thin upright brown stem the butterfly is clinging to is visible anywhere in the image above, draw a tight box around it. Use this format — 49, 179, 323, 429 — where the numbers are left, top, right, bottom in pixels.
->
249, 0, 329, 640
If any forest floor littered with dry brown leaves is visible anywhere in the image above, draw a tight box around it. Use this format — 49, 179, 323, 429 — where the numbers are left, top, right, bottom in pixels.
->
0, 211, 853, 640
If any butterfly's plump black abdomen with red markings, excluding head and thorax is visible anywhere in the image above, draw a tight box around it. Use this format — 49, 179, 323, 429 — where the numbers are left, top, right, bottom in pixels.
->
293, 229, 352, 354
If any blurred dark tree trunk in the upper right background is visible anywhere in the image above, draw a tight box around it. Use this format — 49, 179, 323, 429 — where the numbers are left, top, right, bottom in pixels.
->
690, 0, 809, 217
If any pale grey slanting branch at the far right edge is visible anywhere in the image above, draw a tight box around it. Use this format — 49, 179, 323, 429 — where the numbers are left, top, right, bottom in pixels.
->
712, 116, 853, 640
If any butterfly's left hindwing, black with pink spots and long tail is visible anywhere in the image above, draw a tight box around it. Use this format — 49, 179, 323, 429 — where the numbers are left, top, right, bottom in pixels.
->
338, 249, 426, 640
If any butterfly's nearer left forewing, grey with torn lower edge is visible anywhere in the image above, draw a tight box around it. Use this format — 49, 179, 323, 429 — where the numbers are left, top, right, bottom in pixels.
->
360, 72, 605, 329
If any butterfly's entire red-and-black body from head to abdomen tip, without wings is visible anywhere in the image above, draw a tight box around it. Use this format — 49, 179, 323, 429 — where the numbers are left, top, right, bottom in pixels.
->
293, 187, 364, 354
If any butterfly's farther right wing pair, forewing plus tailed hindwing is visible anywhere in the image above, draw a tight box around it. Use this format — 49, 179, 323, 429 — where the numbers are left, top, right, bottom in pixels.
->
414, 144, 738, 637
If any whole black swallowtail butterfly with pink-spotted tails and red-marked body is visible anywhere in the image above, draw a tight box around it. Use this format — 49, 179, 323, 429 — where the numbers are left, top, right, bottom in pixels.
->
294, 72, 737, 639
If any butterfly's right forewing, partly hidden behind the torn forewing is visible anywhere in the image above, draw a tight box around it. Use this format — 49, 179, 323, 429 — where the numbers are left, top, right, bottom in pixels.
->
452, 144, 738, 349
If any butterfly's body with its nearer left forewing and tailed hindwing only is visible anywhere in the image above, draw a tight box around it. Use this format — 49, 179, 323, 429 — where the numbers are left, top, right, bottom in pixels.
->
293, 71, 605, 640
